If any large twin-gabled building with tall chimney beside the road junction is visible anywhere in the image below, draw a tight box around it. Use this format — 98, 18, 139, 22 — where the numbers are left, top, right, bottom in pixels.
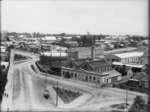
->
61, 47, 122, 86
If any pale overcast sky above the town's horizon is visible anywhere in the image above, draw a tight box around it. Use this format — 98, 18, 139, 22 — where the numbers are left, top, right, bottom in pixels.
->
1, 0, 148, 35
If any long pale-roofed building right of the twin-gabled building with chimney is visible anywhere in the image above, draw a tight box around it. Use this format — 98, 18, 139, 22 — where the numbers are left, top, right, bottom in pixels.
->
106, 51, 145, 76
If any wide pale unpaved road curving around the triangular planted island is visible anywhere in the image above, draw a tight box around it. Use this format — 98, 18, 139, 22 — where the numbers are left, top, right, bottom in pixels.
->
1, 51, 148, 111
